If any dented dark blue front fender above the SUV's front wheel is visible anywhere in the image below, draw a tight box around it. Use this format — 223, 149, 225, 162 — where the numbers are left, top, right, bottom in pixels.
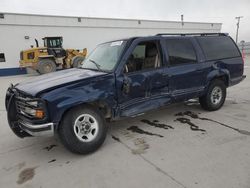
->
42, 75, 116, 123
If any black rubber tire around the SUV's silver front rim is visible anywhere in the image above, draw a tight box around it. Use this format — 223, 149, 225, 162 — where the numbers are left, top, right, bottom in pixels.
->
58, 106, 107, 154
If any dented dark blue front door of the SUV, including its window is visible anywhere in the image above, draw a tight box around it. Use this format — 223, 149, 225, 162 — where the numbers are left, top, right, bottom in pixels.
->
117, 40, 166, 117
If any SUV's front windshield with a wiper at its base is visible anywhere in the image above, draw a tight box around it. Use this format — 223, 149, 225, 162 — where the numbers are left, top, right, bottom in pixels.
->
82, 41, 126, 71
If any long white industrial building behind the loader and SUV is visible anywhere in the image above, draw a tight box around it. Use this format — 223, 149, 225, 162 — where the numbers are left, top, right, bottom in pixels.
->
0, 13, 222, 76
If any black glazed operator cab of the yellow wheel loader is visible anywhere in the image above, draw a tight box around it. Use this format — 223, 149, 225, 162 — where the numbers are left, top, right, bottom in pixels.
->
43, 37, 66, 58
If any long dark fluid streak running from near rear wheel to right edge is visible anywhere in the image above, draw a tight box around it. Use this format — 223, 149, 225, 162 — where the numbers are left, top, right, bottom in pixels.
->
175, 111, 250, 136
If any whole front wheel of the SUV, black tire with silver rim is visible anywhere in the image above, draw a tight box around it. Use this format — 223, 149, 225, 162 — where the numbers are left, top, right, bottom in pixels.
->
58, 106, 107, 154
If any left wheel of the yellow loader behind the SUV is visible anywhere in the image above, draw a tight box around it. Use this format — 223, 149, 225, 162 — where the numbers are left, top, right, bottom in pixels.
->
37, 59, 56, 74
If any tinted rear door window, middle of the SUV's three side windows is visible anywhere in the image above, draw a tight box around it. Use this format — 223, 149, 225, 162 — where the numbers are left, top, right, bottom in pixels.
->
166, 39, 196, 66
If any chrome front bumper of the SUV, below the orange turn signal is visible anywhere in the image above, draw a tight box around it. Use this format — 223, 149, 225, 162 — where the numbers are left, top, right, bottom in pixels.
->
18, 121, 54, 136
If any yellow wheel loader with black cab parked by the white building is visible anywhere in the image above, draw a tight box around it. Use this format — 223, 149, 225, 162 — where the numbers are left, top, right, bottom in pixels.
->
19, 37, 87, 74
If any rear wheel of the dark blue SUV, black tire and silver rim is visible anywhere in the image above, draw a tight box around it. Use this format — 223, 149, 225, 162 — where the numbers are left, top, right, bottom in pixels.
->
199, 79, 227, 111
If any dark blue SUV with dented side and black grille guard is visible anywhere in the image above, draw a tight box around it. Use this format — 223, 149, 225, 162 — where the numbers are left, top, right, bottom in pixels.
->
6, 33, 245, 153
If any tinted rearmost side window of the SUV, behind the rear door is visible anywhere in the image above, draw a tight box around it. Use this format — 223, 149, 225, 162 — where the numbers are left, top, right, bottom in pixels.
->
197, 36, 240, 61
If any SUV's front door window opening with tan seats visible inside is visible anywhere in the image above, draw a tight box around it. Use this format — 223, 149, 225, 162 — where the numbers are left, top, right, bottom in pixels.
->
124, 42, 161, 73
